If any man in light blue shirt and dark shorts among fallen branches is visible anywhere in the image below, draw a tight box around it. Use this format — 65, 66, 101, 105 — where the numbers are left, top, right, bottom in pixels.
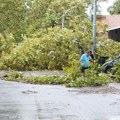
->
80, 51, 94, 77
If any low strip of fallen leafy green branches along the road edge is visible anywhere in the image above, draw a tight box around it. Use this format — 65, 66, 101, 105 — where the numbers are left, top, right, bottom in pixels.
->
2, 62, 120, 87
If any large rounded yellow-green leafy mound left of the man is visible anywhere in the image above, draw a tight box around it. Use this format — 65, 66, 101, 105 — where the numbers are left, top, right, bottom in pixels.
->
0, 28, 77, 70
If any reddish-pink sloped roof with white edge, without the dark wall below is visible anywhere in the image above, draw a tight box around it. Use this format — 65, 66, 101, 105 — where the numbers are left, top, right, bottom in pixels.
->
97, 15, 120, 30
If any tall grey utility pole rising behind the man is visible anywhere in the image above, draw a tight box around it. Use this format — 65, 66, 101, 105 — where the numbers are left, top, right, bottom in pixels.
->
92, 0, 97, 55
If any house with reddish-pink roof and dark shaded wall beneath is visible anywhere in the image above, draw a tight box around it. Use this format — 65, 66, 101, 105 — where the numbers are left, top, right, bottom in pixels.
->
97, 15, 120, 42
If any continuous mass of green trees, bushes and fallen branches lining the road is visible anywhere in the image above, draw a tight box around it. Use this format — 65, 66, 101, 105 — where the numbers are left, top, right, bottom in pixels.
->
0, 0, 120, 87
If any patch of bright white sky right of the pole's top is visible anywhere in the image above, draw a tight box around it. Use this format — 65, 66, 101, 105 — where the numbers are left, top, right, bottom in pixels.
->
99, 0, 115, 15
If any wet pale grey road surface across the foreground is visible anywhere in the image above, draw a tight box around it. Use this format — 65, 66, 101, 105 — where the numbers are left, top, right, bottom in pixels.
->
0, 80, 120, 120
